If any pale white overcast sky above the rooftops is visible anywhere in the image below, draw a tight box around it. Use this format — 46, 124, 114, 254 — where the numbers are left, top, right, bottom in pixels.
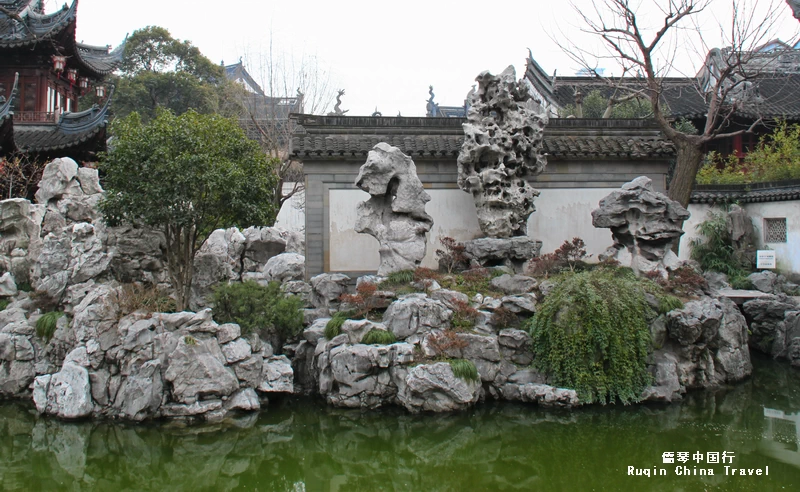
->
45, 0, 798, 116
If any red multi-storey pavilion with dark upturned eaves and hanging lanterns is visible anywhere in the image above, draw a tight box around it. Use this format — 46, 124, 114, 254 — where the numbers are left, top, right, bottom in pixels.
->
0, 0, 124, 161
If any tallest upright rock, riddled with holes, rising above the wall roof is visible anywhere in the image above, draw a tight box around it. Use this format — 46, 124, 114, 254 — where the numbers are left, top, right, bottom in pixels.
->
458, 66, 548, 237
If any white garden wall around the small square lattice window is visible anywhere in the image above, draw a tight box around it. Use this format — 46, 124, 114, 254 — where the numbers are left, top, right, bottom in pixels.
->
679, 200, 800, 273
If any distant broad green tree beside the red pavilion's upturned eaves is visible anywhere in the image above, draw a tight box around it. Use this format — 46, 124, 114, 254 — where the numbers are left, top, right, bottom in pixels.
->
108, 26, 243, 121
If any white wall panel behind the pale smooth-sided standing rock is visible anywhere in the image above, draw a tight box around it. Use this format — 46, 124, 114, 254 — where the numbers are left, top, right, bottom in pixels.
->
328, 189, 480, 272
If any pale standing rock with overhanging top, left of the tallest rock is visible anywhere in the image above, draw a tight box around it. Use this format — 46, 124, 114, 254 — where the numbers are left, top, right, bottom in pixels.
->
355, 142, 433, 275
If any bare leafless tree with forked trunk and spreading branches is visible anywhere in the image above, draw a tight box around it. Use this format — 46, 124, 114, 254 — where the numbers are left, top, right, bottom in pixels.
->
556, 0, 796, 206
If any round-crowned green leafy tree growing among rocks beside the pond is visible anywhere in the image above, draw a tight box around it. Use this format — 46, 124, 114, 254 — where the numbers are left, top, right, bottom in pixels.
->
100, 109, 276, 310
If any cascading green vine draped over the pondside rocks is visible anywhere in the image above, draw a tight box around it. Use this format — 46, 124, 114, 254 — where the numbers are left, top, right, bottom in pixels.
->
528, 268, 652, 404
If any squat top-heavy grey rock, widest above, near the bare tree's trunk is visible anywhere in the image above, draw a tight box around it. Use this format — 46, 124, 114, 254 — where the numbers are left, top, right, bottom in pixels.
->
592, 176, 689, 273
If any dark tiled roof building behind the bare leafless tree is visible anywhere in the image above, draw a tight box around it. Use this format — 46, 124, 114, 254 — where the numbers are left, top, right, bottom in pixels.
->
525, 40, 800, 157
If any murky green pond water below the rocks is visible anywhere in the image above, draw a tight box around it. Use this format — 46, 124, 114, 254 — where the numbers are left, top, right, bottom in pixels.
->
0, 359, 800, 492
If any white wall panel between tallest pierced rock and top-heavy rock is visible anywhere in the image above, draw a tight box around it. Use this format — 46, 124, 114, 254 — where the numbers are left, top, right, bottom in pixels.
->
528, 188, 616, 261
